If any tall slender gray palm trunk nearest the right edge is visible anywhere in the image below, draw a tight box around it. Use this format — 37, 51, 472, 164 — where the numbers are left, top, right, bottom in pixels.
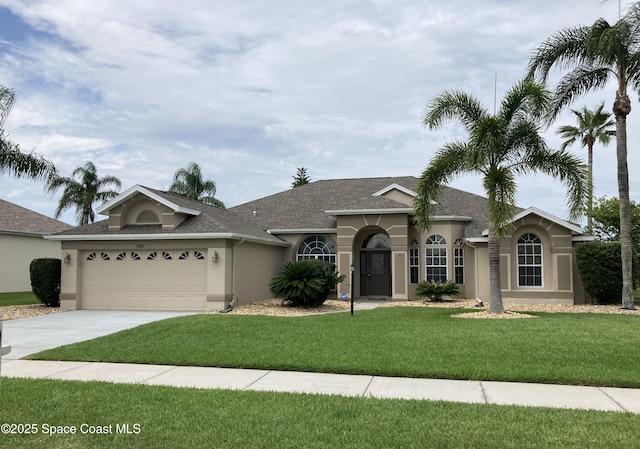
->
613, 92, 635, 310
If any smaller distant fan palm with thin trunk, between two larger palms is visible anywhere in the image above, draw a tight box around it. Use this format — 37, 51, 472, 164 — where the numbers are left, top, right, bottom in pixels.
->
558, 102, 616, 232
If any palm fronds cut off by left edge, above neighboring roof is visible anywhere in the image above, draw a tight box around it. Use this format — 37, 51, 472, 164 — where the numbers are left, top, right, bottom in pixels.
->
0, 85, 55, 179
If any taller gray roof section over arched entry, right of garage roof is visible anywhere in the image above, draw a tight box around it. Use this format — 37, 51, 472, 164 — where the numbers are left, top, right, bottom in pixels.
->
231, 176, 498, 236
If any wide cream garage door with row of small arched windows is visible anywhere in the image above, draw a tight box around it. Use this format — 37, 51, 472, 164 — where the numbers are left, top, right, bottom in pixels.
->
80, 249, 207, 310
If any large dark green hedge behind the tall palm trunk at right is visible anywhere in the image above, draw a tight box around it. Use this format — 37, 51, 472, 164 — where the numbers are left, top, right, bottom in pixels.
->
576, 242, 638, 304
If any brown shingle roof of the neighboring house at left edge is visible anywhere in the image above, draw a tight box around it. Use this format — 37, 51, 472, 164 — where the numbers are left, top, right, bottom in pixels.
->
0, 199, 73, 235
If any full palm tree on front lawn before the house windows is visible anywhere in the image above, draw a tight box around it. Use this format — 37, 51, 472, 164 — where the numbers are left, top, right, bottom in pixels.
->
414, 79, 587, 313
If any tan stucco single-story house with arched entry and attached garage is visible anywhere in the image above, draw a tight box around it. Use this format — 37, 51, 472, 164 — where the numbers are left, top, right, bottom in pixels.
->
47, 176, 590, 310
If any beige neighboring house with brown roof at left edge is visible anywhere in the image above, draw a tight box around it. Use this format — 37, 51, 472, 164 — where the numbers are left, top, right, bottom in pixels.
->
0, 199, 73, 293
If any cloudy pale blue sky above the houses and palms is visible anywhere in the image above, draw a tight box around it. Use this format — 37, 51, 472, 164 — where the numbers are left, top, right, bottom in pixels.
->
0, 0, 640, 224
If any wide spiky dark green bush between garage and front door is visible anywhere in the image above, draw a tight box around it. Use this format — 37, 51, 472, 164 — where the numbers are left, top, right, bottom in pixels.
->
269, 259, 344, 307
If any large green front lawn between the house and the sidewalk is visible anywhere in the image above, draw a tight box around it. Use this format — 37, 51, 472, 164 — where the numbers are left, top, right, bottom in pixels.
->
31, 307, 640, 388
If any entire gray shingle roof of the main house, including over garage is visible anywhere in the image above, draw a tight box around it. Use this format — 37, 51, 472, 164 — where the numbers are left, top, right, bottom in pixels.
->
52, 176, 522, 243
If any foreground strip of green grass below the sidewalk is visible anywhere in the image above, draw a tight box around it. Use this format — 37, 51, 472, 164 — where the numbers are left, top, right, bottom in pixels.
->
0, 379, 640, 449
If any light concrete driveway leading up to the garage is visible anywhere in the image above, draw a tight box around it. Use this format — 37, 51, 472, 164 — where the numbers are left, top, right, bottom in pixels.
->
2, 310, 194, 360
